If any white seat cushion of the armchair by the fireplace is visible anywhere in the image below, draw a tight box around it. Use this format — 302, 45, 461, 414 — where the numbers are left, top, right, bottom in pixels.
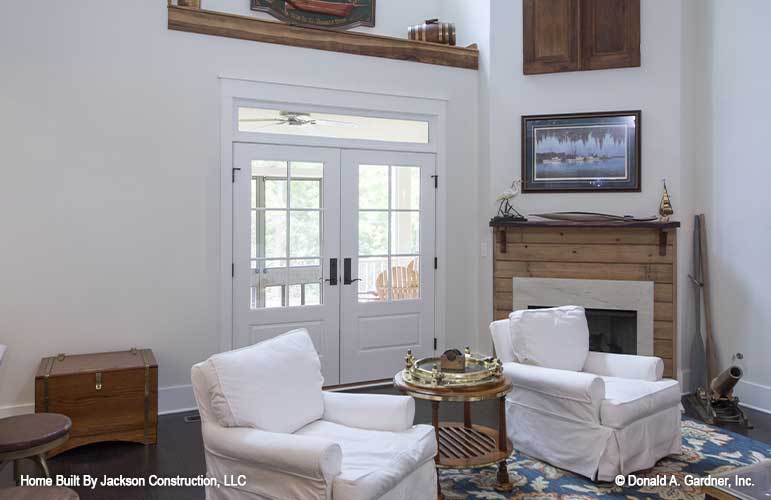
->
600, 377, 682, 429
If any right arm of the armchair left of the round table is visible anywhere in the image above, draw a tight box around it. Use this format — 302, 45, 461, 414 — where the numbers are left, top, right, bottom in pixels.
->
321, 391, 415, 432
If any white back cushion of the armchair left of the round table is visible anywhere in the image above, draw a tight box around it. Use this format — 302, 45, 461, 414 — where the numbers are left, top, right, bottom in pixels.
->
208, 329, 324, 433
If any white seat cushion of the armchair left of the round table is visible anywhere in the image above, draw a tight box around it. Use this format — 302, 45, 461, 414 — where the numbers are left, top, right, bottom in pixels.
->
296, 420, 437, 500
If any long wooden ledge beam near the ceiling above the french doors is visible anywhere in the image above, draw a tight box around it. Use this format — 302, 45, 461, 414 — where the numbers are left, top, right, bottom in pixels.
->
168, 5, 479, 69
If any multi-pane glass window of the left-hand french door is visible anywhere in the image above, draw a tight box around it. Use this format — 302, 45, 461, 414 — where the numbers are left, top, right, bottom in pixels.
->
250, 156, 324, 309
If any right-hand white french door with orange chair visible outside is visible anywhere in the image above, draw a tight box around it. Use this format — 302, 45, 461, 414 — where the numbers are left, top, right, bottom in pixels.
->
340, 150, 435, 384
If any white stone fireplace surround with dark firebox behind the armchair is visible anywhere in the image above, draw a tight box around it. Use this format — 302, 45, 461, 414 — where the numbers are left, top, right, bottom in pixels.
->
512, 278, 653, 355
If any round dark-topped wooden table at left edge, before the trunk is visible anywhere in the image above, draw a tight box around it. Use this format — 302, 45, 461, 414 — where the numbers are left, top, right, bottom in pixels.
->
0, 413, 72, 485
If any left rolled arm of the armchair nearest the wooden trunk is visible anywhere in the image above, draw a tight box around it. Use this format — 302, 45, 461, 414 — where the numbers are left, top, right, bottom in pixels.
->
203, 423, 343, 482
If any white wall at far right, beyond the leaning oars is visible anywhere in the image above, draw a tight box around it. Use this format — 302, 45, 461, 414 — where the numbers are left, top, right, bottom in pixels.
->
703, 0, 771, 411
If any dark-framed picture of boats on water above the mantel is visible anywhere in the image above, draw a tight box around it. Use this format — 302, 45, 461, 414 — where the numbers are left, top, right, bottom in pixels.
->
522, 110, 641, 193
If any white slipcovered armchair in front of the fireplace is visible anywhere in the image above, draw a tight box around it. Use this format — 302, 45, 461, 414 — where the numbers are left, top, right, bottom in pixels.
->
490, 306, 681, 481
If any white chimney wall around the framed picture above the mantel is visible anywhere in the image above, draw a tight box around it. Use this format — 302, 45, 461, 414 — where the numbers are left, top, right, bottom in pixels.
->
478, 0, 688, 372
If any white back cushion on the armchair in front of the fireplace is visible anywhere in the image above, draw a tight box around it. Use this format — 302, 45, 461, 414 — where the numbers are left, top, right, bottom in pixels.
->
509, 306, 589, 371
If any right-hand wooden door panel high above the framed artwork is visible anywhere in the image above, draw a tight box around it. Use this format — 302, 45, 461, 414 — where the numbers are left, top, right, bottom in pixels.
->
581, 0, 640, 69
